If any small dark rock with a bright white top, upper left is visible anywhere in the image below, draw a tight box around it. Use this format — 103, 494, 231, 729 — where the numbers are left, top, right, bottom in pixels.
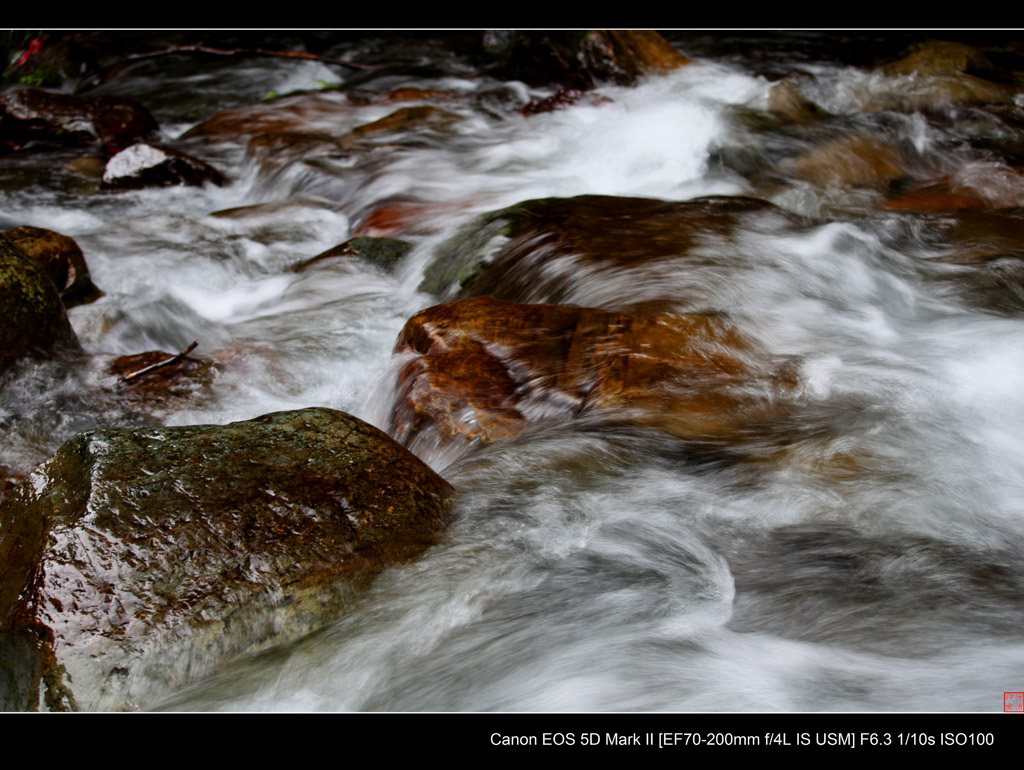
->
100, 143, 224, 190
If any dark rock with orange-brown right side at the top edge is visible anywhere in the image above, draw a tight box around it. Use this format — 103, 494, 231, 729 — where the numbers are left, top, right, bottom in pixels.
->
504, 30, 690, 90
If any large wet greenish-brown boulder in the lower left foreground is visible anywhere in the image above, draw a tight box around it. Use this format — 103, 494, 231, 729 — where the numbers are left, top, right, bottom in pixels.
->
0, 409, 452, 711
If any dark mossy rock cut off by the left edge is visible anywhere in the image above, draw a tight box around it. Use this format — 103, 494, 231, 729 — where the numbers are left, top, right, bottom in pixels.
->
0, 238, 79, 372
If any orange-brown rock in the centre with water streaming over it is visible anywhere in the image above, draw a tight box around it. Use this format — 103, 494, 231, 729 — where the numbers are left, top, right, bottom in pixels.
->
392, 297, 792, 444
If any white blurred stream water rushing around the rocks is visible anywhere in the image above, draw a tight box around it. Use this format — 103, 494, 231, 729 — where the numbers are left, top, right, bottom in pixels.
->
0, 35, 1024, 711
